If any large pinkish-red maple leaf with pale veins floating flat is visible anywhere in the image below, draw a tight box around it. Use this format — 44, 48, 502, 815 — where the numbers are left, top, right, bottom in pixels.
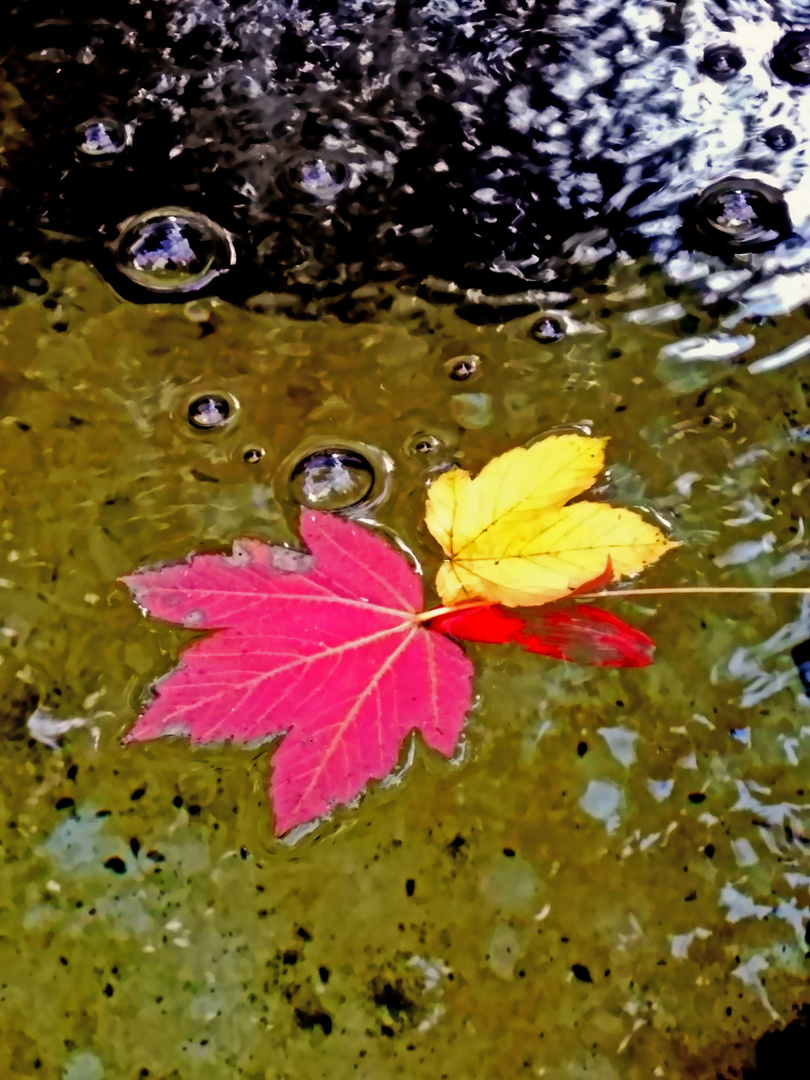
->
124, 511, 473, 834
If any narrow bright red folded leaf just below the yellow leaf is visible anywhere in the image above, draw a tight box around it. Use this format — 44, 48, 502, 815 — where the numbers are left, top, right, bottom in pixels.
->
431, 604, 656, 667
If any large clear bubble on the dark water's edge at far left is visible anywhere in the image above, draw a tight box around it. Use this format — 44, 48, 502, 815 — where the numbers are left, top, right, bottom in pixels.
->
116, 206, 235, 294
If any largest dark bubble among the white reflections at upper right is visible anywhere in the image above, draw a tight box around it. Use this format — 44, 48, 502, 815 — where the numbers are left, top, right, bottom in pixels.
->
692, 176, 791, 252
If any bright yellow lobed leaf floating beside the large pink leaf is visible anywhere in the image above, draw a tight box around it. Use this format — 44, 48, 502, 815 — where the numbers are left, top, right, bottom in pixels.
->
424, 435, 677, 607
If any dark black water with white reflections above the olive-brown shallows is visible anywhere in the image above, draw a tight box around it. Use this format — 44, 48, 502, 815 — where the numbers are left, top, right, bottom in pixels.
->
1, 0, 810, 316
